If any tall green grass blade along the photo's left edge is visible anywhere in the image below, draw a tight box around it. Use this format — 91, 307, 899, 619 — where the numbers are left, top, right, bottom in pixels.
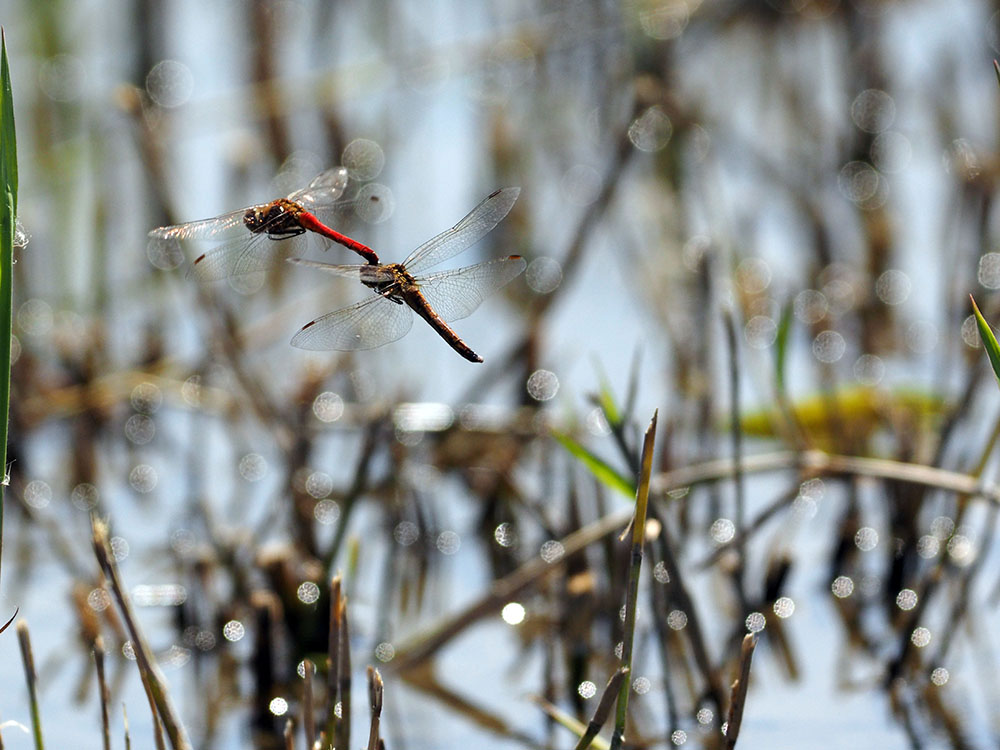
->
0, 30, 17, 592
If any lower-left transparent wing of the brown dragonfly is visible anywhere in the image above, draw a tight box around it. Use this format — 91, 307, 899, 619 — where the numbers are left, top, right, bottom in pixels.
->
292, 295, 413, 352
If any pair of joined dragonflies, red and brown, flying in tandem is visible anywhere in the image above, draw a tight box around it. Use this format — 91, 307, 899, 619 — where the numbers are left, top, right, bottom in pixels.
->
149, 167, 525, 362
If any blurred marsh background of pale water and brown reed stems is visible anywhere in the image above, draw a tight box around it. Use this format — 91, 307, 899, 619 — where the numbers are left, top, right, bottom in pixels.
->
0, 0, 1000, 750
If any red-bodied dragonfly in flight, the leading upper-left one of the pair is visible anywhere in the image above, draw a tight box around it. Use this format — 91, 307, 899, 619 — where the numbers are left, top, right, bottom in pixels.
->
149, 167, 380, 281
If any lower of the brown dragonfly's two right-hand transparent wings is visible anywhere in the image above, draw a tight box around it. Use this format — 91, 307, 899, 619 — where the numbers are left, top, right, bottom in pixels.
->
417, 255, 527, 321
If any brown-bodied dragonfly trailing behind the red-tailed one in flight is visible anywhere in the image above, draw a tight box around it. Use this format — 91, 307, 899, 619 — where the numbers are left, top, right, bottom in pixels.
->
289, 188, 526, 362
